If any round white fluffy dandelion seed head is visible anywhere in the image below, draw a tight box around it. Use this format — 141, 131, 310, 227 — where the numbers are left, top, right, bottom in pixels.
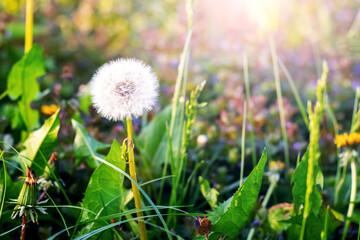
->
90, 58, 159, 121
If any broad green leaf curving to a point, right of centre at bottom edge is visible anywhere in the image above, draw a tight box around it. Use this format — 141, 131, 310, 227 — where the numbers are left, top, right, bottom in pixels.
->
209, 149, 267, 240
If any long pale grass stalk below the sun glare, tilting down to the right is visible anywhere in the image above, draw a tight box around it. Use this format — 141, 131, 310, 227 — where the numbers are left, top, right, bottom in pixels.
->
270, 38, 290, 168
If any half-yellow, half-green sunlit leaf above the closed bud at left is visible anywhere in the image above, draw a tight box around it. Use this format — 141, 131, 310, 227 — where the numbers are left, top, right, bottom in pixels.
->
20, 109, 60, 176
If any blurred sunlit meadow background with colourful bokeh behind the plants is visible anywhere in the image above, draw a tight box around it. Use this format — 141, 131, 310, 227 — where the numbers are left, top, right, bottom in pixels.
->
0, 0, 360, 211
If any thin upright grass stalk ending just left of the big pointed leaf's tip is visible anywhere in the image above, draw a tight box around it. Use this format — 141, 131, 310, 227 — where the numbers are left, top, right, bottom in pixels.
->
243, 53, 257, 167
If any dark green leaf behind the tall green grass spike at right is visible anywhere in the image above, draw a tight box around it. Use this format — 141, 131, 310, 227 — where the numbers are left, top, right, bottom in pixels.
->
291, 151, 323, 214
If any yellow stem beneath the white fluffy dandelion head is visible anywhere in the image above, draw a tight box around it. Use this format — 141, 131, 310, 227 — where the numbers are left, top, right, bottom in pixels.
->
126, 118, 147, 240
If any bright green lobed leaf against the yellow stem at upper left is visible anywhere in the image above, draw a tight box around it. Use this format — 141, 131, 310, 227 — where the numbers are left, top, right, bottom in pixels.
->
7, 45, 45, 131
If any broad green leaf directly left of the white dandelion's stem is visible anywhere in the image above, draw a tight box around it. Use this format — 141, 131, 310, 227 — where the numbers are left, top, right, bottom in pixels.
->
81, 140, 132, 239
